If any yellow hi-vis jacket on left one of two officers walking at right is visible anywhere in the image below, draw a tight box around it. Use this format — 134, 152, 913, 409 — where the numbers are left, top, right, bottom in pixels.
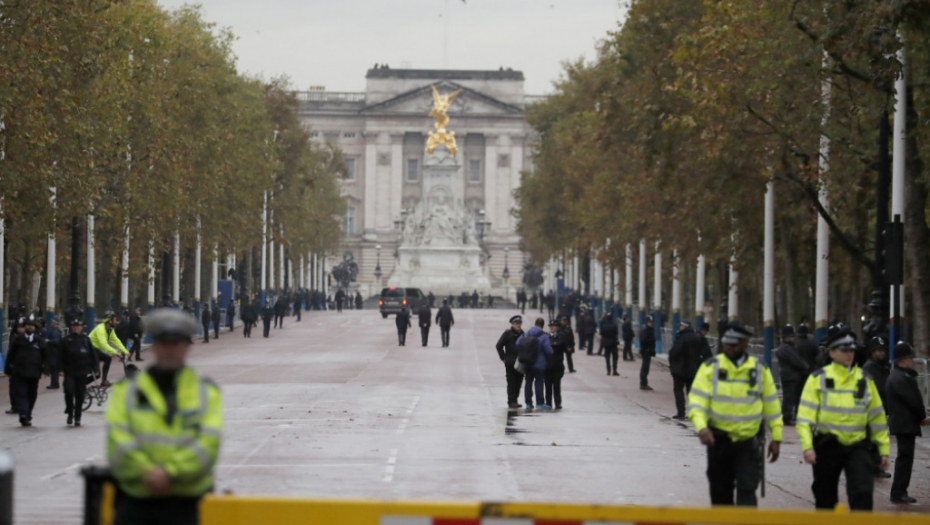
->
688, 353, 784, 441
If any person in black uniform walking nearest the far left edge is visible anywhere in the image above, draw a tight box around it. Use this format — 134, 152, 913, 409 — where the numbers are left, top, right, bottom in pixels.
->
3, 315, 48, 427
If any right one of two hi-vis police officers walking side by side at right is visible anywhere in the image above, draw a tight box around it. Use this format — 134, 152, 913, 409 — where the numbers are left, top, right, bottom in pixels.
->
798, 323, 890, 510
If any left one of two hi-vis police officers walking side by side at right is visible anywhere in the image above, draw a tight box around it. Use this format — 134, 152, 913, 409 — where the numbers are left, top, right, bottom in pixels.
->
688, 323, 783, 507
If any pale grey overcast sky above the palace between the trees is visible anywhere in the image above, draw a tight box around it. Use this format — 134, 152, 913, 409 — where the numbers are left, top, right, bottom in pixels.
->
159, 0, 625, 94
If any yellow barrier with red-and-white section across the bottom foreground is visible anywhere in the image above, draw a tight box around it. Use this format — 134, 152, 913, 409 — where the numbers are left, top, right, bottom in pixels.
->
201, 496, 930, 525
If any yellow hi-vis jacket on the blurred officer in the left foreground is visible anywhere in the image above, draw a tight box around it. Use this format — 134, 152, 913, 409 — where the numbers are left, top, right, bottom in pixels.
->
107, 368, 223, 498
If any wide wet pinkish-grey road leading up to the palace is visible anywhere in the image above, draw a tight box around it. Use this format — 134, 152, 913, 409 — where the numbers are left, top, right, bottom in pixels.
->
0, 310, 930, 525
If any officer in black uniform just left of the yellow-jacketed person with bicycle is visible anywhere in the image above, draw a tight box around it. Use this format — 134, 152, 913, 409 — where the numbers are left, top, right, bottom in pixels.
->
58, 316, 100, 427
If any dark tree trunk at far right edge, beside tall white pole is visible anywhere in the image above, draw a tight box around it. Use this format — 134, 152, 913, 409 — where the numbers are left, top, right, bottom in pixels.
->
904, 89, 930, 356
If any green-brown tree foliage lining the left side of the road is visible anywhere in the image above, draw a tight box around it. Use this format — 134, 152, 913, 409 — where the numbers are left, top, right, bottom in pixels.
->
0, 0, 344, 312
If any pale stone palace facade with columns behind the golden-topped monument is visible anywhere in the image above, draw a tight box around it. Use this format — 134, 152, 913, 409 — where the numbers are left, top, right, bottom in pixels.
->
297, 66, 538, 297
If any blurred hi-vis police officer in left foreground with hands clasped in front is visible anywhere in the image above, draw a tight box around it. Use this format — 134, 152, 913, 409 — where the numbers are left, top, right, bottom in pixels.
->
107, 309, 223, 525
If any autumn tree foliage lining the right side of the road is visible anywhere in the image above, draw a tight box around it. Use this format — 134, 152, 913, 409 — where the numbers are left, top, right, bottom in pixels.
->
516, 0, 930, 349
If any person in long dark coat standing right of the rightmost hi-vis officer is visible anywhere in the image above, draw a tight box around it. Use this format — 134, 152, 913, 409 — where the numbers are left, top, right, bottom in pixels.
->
885, 343, 930, 503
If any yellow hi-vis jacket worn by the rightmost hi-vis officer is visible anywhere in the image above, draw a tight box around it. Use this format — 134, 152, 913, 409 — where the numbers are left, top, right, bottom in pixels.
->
797, 363, 891, 456
